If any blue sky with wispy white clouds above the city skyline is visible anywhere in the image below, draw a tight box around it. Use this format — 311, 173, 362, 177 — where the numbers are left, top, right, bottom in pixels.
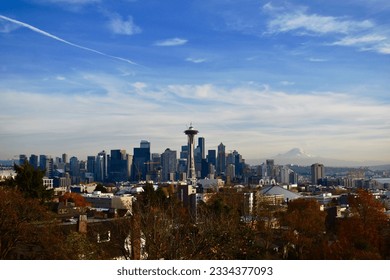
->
0, 0, 390, 163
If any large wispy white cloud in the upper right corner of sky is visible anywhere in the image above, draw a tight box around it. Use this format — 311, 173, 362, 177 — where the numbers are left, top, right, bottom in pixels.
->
263, 3, 390, 54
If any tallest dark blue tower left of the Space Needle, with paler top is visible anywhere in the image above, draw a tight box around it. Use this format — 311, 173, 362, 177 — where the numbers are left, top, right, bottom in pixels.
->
131, 140, 150, 181
